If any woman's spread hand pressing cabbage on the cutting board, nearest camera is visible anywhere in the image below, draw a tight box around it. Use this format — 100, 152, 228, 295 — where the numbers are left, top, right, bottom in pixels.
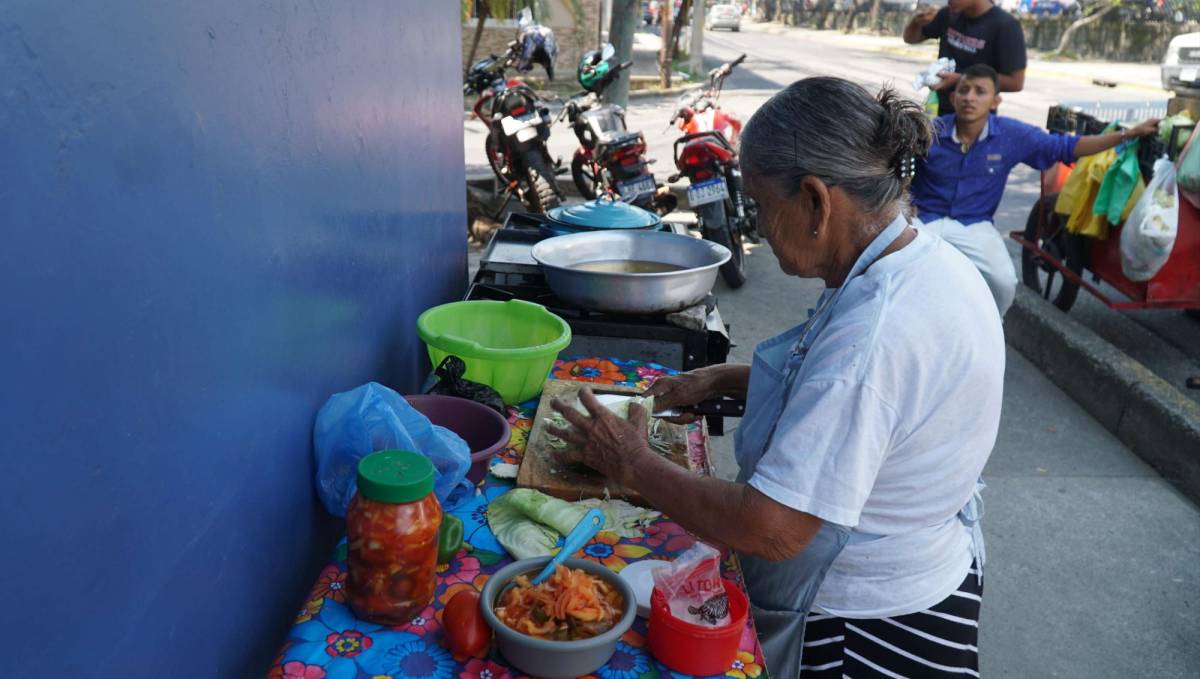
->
546, 386, 654, 487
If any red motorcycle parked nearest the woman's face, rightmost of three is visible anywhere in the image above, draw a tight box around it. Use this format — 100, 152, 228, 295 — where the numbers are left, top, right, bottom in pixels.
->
667, 54, 758, 288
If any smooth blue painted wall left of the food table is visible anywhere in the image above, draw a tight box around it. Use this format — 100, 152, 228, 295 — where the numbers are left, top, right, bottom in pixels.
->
0, 0, 466, 679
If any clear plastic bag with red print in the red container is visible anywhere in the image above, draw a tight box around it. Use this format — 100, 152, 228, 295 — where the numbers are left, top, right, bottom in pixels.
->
653, 542, 730, 626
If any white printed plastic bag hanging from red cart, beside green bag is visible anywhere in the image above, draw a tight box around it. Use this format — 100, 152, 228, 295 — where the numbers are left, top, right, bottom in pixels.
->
1121, 157, 1180, 281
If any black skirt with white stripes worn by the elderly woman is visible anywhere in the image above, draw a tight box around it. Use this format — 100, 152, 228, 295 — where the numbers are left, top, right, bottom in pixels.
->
800, 565, 983, 679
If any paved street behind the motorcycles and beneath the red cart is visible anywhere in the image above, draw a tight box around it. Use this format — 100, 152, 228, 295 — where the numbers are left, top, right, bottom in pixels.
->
466, 23, 1200, 401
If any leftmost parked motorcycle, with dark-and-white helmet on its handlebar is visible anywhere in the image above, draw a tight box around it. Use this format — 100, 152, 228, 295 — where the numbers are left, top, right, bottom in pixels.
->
463, 16, 563, 212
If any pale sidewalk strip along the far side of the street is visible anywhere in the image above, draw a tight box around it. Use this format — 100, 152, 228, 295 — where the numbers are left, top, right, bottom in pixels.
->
742, 22, 1163, 95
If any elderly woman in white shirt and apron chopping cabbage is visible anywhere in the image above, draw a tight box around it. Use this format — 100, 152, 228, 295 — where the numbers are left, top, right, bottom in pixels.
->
556, 78, 1004, 678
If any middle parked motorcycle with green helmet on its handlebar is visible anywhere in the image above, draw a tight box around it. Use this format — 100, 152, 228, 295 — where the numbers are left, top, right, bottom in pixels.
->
559, 44, 677, 215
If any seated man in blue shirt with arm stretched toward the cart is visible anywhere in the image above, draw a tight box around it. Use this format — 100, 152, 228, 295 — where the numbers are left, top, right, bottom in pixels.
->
912, 64, 1158, 316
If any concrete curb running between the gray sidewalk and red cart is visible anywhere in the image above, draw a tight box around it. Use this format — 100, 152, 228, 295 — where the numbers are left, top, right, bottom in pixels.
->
1004, 286, 1200, 503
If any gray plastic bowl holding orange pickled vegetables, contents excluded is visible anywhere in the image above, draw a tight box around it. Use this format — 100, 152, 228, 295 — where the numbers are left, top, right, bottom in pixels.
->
479, 557, 637, 679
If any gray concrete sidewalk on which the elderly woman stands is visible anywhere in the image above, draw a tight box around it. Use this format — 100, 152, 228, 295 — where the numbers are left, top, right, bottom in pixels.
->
712, 239, 1200, 679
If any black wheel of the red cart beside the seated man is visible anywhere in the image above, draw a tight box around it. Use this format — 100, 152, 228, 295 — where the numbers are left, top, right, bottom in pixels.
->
1021, 193, 1087, 311
